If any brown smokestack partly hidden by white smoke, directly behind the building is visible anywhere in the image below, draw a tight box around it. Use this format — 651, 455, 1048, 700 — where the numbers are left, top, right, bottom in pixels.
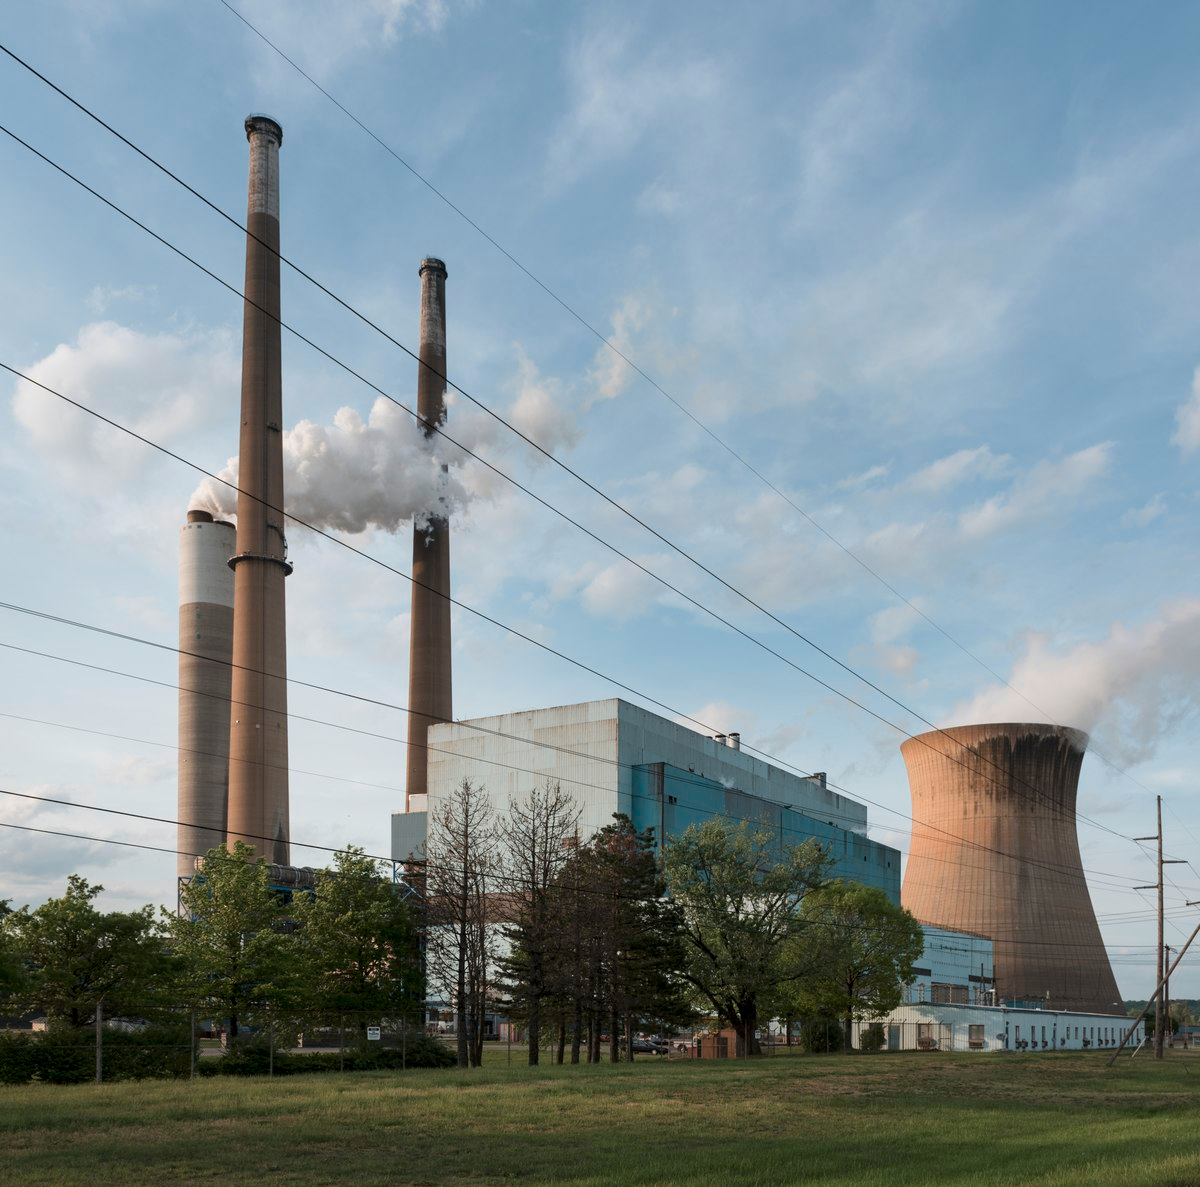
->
404, 252, 454, 811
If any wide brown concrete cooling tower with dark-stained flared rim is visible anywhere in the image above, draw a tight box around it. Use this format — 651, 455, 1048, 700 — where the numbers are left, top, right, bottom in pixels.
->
900, 725, 1121, 1014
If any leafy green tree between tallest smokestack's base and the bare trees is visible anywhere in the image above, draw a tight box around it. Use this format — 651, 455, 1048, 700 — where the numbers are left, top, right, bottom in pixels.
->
292, 846, 421, 1037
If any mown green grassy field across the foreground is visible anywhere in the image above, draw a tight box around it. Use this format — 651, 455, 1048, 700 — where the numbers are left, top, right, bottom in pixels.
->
0, 1053, 1200, 1187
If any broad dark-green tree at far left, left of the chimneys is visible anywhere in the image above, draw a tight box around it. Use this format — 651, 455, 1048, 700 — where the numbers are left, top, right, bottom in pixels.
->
4, 874, 166, 1027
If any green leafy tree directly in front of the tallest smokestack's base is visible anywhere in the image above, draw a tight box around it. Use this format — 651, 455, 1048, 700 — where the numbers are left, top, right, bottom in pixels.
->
163, 841, 295, 1039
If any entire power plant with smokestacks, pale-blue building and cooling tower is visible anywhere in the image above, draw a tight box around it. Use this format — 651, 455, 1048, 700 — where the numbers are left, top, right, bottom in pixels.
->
178, 115, 1128, 1051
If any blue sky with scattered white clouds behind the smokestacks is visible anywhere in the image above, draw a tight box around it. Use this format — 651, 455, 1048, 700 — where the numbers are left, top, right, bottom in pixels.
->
0, 0, 1200, 997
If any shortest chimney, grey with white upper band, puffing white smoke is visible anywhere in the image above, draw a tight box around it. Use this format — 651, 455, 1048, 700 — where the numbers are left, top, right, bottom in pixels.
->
175, 511, 234, 877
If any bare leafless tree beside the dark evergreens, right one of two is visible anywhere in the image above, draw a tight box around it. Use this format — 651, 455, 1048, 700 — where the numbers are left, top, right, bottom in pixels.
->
499, 780, 580, 1063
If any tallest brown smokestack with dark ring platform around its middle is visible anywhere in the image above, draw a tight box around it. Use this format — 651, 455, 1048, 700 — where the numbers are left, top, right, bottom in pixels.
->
228, 115, 292, 865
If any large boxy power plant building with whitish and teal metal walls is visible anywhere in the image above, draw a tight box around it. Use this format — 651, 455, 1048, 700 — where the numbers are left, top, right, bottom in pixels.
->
391, 699, 900, 901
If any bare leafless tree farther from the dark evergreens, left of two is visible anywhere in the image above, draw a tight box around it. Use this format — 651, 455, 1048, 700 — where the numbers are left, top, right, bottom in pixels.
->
425, 779, 498, 1067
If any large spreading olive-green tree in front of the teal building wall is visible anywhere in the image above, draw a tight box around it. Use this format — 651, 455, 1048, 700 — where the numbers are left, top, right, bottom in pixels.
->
664, 820, 829, 1055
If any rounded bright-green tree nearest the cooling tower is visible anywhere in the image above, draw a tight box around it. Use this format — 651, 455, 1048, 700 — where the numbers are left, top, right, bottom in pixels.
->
791, 880, 925, 1051
